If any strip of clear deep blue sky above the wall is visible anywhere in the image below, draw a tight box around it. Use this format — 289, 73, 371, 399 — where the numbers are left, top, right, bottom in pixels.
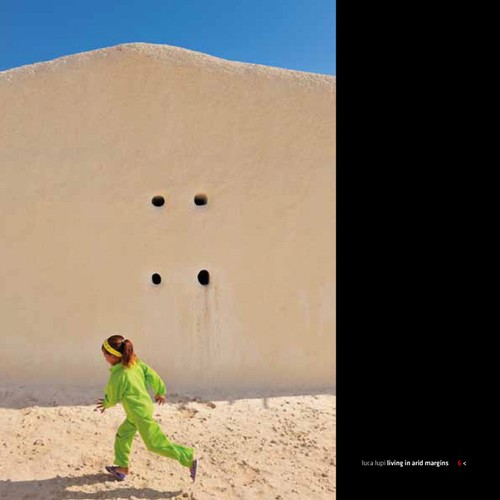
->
0, 0, 336, 75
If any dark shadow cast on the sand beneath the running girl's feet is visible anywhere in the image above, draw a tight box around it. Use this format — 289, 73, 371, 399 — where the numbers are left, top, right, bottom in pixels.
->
0, 473, 182, 500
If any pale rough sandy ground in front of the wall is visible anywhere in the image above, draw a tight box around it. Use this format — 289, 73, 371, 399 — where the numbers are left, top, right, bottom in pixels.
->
0, 387, 336, 500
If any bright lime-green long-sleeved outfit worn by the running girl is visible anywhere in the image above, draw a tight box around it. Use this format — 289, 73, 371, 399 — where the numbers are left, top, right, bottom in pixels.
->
104, 360, 193, 467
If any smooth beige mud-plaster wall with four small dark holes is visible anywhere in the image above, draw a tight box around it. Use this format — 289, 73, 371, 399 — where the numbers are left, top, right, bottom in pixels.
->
0, 44, 336, 394
